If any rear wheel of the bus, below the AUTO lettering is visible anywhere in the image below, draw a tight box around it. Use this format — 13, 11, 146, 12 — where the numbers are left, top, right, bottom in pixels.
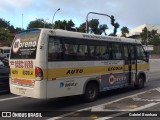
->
83, 82, 99, 102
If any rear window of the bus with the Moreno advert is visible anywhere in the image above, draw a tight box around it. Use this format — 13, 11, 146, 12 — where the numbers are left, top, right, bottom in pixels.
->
10, 29, 40, 59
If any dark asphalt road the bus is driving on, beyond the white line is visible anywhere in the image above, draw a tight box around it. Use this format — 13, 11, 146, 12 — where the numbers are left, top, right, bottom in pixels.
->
0, 60, 160, 120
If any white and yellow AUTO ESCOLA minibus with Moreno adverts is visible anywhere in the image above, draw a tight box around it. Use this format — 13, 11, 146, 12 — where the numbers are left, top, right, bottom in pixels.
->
9, 28, 149, 102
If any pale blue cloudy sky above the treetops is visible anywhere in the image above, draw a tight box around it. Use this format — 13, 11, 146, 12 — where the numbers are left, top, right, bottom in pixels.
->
0, 0, 160, 32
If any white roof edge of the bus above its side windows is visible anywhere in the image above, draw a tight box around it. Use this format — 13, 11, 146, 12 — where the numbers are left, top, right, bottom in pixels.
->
34, 28, 141, 44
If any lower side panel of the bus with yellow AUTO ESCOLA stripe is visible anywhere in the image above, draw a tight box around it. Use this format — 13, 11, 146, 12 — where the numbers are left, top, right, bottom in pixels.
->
47, 60, 128, 98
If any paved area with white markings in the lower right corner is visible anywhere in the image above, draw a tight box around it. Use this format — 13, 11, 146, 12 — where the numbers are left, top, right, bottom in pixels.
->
48, 88, 160, 120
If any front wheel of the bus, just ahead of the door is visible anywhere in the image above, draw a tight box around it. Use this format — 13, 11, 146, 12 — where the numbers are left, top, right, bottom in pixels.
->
134, 75, 145, 89
